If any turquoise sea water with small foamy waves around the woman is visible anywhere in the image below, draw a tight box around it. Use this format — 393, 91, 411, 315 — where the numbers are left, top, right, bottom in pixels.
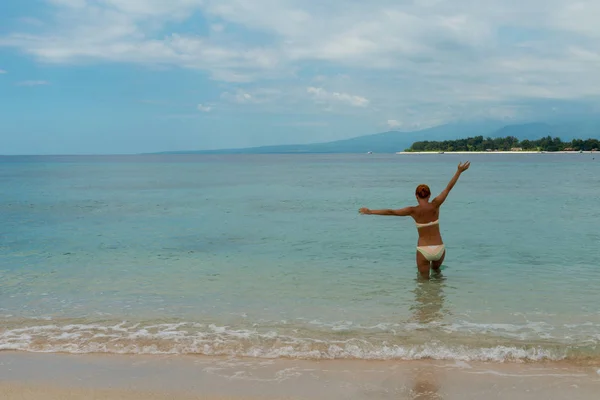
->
0, 154, 600, 361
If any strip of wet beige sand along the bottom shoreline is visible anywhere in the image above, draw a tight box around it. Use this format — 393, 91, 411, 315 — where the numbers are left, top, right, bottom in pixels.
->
0, 352, 600, 400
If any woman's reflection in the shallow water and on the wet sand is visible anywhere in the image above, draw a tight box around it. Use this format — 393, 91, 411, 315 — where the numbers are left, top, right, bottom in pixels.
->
411, 273, 445, 400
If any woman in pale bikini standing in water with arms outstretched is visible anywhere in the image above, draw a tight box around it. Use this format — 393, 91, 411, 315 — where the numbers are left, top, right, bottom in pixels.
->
359, 161, 471, 279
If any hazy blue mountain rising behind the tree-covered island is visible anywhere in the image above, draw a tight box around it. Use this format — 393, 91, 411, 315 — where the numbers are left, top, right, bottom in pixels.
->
160, 120, 600, 154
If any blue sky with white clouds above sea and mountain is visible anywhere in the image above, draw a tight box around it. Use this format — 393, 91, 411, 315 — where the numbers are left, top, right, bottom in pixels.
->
0, 0, 600, 154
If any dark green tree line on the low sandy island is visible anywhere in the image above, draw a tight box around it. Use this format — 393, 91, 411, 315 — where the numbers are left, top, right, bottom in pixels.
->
406, 136, 600, 152
